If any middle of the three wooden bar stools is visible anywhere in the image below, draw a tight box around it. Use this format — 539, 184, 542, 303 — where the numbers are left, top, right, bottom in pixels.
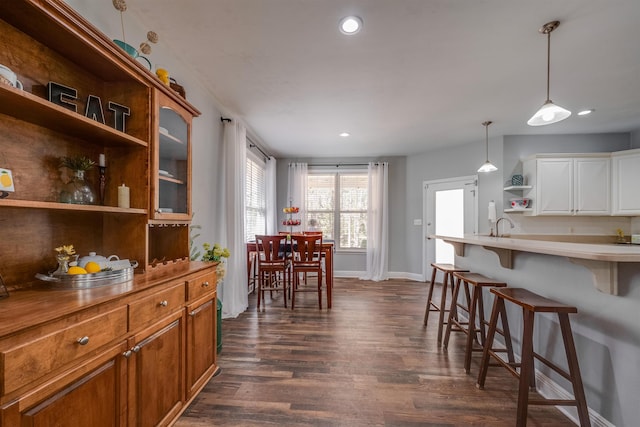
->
442, 272, 513, 373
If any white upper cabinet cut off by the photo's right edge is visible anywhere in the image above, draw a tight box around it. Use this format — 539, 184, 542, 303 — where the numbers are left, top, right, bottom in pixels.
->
611, 149, 640, 216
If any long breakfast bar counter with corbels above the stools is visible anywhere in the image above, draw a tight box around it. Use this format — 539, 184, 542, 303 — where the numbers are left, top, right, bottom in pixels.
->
432, 234, 640, 295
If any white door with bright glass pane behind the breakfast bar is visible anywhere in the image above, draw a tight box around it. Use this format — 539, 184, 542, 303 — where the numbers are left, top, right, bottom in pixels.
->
422, 176, 478, 280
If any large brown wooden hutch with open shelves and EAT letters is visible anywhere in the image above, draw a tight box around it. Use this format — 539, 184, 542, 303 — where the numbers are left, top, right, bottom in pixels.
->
0, 0, 217, 427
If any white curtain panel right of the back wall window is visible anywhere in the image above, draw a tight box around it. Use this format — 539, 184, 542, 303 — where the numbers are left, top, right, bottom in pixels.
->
360, 162, 389, 281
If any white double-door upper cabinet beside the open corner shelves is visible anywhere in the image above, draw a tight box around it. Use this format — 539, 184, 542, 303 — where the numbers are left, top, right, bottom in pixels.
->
523, 153, 611, 216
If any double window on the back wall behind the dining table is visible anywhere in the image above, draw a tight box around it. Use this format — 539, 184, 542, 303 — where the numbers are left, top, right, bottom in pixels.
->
306, 172, 368, 249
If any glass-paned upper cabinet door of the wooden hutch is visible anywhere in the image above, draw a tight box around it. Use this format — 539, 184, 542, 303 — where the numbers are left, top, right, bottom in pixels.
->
151, 93, 193, 221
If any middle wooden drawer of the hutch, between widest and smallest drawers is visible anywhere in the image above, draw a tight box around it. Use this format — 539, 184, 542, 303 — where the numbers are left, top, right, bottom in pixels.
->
129, 282, 184, 331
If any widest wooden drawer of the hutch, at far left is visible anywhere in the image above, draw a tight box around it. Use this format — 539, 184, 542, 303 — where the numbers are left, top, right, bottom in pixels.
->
0, 306, 127, 395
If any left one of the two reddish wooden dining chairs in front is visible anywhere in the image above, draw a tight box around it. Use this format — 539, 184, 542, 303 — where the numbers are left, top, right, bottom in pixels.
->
256, 235, 291, 310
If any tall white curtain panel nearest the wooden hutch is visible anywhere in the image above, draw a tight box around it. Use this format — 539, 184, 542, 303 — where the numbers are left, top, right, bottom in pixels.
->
219, 120, 249, 318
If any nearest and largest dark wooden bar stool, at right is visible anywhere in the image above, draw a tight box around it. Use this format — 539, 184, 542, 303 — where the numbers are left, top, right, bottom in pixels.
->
477, 288, 591, 427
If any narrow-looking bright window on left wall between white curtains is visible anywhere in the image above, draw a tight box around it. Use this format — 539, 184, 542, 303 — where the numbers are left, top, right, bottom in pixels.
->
244, 153, 267, 242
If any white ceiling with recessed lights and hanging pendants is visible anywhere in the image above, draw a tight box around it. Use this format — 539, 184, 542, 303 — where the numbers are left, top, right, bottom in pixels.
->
129, 0, 640, 157
